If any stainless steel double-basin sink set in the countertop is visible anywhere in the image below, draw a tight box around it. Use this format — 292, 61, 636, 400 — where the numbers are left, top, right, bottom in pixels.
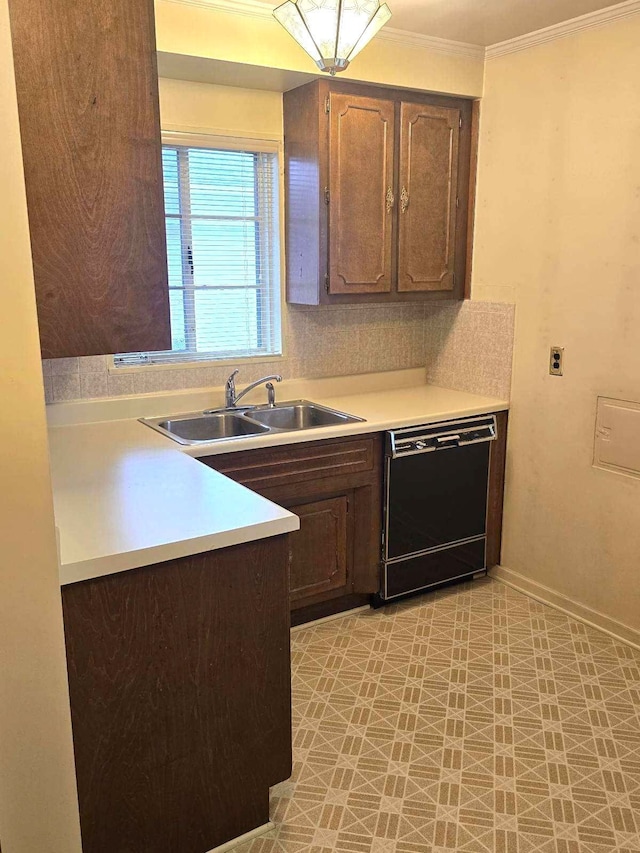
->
140, 400, 364, 444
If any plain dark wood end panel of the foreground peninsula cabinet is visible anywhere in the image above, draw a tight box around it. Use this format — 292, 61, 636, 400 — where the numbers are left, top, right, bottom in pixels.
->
62, 536, 291, 853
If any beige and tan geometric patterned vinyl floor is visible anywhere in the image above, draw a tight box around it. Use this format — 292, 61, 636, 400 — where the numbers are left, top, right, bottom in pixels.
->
236, 579, 640, 853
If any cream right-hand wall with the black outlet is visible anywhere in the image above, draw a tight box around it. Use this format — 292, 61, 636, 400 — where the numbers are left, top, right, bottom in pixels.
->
473, 17, 640, 639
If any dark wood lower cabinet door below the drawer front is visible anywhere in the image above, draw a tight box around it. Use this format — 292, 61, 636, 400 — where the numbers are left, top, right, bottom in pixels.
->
288, 495, 350, 608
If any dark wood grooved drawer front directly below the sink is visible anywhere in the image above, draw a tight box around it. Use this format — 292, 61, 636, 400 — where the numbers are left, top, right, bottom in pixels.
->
200, 436, 379, 492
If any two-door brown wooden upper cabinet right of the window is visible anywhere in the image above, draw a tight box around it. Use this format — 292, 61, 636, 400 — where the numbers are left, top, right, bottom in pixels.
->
284, 80, 474, 305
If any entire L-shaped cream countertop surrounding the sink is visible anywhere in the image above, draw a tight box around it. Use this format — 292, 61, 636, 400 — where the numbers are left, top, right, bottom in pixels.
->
49, 372, 509, 584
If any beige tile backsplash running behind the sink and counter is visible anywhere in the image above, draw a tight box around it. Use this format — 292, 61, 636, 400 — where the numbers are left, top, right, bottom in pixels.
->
43, 302, 513, 402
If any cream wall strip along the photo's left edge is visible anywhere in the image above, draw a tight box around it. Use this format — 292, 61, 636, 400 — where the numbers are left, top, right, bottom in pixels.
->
0, 0, 80, 853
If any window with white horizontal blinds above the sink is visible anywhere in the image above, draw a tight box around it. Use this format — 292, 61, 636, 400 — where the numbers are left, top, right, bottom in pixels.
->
115, 134, 282, 366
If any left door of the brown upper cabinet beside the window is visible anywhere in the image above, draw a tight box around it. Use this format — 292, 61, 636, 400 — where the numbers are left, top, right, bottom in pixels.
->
329, 93, 395, 293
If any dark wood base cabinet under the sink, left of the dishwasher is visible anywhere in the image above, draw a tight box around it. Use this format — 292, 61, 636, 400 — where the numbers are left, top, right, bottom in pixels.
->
200, 433, 383, 624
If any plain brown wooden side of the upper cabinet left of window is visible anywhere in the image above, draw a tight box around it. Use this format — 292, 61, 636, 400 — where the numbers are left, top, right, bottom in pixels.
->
9, 0, 171, 358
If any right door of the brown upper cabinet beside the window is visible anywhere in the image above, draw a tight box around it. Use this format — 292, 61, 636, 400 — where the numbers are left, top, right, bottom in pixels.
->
398, 103, 460, 292
